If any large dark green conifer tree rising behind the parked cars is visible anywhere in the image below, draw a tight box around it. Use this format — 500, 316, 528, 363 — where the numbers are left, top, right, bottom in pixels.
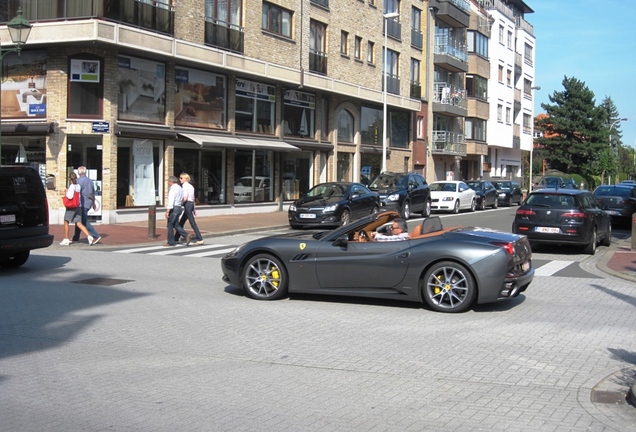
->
536, 76, 608, 180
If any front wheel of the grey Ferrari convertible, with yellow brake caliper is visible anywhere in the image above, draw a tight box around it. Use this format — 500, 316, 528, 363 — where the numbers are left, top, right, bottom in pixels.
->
241, 254, 289, 300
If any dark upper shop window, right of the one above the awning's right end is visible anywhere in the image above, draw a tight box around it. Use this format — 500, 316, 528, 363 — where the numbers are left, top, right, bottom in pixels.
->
283, 90, 316, 138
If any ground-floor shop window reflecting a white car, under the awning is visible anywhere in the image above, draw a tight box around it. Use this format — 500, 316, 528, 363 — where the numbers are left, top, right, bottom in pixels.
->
234, 150, 274, 204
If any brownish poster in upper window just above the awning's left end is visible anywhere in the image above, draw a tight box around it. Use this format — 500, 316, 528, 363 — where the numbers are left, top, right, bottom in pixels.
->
174, 66, 226, 129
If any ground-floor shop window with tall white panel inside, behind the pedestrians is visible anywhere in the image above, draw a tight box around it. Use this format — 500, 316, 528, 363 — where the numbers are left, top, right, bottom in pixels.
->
117, 138, 165, 207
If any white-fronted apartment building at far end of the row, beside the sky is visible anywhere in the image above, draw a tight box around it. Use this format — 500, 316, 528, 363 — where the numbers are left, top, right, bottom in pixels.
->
473, 0, 537, 183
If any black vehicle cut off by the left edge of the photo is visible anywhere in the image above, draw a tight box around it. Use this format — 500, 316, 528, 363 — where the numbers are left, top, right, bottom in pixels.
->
0, 166, 53, 268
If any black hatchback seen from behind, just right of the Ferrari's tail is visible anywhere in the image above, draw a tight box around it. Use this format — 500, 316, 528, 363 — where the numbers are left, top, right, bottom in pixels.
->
512, 189, 612, 255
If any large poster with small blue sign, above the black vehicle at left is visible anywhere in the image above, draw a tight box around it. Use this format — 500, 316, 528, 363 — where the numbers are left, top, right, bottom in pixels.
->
0, 51, 47, 119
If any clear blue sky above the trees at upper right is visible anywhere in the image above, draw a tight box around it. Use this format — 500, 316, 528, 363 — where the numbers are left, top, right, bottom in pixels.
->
525, 0, 636, 152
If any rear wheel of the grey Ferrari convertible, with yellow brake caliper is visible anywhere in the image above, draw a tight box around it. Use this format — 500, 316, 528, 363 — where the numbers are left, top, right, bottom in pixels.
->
421, 261, 477, 312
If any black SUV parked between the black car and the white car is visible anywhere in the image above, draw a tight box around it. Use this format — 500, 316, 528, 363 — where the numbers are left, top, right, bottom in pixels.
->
369, 172, 431, 219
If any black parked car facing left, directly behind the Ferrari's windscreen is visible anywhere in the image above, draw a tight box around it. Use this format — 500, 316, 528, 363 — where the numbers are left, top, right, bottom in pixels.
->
287, 182, 380, 228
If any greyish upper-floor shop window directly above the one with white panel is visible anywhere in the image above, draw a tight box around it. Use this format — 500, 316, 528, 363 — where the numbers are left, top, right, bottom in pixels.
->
117, 56, 166, 124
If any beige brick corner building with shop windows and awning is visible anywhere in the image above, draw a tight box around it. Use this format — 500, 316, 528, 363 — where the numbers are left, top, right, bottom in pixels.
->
0, 0, 424, 223
